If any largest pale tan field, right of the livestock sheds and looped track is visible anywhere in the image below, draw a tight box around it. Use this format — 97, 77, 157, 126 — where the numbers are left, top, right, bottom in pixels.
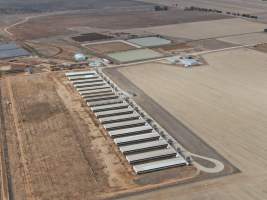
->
116, 49, 267, 200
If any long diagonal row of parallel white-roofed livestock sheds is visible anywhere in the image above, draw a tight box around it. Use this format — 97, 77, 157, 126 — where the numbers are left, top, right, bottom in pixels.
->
66, 71, 188, 174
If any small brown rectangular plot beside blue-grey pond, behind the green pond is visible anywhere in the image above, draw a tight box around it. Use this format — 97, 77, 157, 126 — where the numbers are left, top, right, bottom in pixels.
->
85, 42, 136, 54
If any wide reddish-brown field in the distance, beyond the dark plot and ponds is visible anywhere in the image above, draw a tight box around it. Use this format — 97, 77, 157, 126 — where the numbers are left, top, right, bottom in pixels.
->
10, 9, 229, 39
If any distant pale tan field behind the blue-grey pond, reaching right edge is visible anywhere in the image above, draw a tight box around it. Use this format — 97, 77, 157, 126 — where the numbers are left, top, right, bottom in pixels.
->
140, 18, 266, 40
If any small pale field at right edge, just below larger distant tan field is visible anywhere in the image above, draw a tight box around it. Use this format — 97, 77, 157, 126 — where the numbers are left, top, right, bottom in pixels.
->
218, 33, 267, 45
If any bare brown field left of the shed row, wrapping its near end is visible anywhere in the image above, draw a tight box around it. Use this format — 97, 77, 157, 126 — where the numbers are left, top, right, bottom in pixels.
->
0, 73, 199, 200
